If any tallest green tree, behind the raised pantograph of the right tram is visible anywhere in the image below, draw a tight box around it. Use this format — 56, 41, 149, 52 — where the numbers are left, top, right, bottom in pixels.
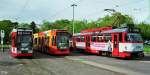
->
96, 12, 133, 27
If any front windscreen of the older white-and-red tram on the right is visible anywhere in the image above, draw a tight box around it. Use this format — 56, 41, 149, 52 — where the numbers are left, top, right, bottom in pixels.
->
127, 33, 143, 42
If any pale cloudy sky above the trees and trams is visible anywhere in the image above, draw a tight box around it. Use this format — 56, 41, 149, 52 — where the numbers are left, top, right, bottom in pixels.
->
0, 0, 150, 24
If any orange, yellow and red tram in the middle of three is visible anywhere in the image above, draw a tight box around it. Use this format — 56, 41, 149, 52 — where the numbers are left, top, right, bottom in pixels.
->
33, 29, 71, 55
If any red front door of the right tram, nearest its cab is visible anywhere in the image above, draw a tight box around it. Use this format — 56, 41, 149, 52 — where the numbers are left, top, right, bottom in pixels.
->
112, 34, 119, 56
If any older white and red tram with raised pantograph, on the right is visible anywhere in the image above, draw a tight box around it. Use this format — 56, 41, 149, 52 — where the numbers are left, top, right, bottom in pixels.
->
73, 27, 144, 59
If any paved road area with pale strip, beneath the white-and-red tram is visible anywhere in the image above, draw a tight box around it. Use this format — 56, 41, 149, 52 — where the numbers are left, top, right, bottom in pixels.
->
69, 53, 150, 75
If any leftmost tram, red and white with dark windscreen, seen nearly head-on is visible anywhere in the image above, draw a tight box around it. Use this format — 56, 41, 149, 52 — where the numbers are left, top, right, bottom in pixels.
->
10, 28, 33, 57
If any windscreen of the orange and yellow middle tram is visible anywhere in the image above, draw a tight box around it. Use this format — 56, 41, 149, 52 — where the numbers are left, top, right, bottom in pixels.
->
56, 32, 70, 49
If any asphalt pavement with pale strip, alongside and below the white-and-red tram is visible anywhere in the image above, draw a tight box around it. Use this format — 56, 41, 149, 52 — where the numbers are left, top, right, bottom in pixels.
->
68, 52, 150, 75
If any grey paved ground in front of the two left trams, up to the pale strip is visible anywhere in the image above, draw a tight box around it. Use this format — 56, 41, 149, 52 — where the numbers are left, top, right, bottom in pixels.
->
0, 52, 123, 75
